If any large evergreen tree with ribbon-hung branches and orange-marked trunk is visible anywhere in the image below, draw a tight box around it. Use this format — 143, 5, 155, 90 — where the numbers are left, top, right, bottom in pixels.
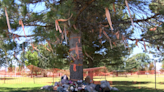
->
0, 0, 164, 80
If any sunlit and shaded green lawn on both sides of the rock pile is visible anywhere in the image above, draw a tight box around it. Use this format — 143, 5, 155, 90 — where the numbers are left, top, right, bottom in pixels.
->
0, 75, 164, 92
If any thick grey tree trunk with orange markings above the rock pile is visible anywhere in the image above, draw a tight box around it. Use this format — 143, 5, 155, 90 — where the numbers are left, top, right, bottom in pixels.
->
69, 33, 83, 81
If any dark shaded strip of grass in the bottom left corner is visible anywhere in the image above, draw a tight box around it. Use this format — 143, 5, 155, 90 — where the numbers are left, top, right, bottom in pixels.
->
0, 87, 54, 92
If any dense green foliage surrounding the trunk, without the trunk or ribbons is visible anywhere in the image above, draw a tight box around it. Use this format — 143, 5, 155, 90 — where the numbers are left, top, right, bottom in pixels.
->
0, 0, 164, 68
